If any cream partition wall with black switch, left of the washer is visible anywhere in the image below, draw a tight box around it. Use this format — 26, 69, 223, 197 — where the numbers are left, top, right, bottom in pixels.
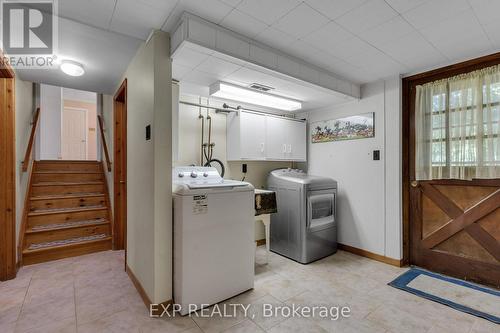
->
113, 31, 172, 303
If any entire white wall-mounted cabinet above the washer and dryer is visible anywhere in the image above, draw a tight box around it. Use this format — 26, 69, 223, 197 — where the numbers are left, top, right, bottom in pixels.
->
227, 111, 307, 161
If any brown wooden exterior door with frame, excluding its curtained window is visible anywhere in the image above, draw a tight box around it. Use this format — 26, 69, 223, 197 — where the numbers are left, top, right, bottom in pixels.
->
403, 53, 500, 287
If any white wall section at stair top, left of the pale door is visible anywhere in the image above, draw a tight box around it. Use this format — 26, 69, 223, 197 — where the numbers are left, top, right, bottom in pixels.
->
39, 84, 62, 160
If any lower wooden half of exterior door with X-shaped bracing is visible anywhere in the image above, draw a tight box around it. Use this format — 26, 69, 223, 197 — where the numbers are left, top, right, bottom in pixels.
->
410, 179, 500, 287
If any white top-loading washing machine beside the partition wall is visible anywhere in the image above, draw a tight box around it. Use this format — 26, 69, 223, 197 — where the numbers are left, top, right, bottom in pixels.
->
172, 167, 255, 315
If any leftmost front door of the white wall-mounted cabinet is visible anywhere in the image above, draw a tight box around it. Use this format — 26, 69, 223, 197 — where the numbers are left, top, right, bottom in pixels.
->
239, 112, 267, 160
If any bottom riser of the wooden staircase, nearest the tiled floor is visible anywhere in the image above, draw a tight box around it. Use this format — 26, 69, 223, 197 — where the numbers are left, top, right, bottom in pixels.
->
23, 236, 112, 265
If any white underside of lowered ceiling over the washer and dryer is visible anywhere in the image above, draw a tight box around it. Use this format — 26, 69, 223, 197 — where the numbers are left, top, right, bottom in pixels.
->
172, 42, 354, 111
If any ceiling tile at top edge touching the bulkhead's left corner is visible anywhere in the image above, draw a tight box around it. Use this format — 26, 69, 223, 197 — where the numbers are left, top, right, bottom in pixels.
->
109, 0, 175, 40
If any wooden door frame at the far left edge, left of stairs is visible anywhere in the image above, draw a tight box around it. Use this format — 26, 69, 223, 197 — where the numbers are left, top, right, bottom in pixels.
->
0, 50, 17, 281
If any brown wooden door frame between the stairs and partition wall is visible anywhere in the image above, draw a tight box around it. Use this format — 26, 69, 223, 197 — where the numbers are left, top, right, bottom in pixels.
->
113, 79, 127, 250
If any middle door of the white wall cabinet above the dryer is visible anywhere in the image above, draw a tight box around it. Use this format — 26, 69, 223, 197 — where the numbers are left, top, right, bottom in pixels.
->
266, 116, 288, 160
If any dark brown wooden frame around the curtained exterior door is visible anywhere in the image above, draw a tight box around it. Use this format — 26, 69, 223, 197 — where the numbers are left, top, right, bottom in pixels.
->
402, 52, 500, 265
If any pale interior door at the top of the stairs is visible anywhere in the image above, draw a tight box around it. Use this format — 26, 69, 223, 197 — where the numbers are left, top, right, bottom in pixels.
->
61, 108, 87, 160
